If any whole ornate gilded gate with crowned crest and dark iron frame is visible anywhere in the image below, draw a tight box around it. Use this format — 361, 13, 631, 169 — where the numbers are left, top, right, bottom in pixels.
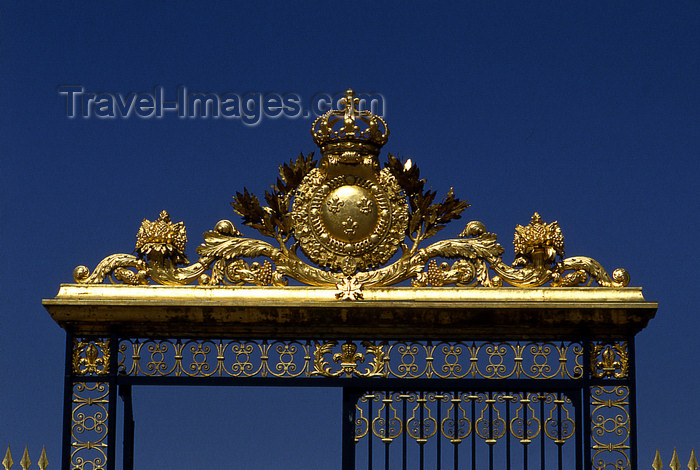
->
44, 90, 657, 470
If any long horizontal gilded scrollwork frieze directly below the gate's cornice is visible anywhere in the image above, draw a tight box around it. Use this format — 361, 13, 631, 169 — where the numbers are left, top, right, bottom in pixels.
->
118, 339, 583, 380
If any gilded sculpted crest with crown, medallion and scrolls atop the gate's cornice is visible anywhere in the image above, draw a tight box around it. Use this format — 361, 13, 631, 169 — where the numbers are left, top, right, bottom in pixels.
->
73, 90, 629, 294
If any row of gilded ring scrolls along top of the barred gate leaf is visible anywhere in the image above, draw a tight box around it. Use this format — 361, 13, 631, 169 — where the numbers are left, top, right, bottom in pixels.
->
355, 391, 576, 446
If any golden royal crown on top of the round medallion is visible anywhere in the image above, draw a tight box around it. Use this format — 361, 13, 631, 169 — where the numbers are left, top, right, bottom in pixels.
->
311, 90, 389, 159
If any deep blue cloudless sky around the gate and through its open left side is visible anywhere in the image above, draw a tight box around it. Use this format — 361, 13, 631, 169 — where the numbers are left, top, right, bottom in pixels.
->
0, 1, 700, 469
